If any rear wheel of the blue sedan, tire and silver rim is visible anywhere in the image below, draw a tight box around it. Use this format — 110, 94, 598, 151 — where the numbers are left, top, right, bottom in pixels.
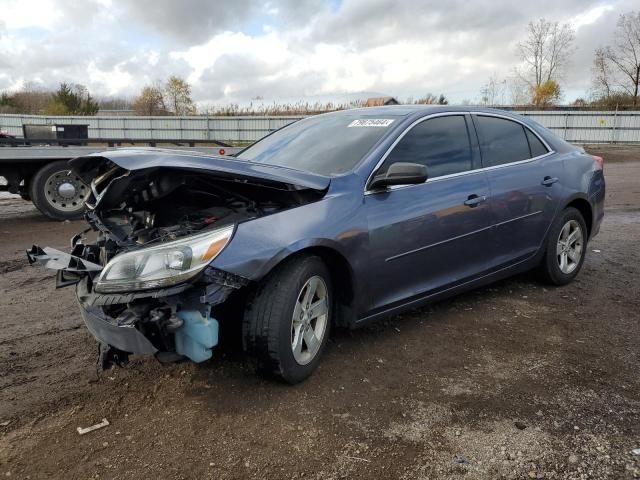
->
540, 207, 588, 286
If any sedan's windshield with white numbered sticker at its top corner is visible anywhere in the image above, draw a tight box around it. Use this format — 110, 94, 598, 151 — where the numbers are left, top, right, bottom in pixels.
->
237, 112, 399, 175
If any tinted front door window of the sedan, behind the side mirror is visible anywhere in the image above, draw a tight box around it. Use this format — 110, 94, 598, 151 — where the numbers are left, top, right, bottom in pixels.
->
379, 115, 473, 178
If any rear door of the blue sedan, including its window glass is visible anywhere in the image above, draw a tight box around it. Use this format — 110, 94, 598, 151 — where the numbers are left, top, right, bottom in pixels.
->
473, 114, 563, 268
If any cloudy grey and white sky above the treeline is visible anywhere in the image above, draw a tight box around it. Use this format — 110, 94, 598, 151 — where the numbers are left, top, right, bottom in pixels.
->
0, 0, 638, 105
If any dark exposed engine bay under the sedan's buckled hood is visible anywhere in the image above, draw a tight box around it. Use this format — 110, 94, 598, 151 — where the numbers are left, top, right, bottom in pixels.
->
86, 169, 317, 265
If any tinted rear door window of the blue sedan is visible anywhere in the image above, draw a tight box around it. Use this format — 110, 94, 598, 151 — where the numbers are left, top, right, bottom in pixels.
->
474, 115, 531, 167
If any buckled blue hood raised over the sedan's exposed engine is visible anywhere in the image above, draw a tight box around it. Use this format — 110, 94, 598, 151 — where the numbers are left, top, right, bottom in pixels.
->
69, 148, 331, 191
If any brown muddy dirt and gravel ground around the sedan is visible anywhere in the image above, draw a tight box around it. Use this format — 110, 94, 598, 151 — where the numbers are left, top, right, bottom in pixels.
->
0, 147, 640, 479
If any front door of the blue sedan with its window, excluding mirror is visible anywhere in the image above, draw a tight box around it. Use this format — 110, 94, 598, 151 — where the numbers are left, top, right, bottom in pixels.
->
364, 114, 490, 315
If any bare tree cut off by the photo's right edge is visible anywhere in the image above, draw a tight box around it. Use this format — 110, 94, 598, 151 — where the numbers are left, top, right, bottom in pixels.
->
596, 11, 640, 107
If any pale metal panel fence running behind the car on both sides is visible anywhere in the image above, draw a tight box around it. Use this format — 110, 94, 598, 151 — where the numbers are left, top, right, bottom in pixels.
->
0, 110, 640, 144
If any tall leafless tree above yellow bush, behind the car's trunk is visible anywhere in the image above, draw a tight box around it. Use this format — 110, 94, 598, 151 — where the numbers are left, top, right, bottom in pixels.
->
518, 18, 575, 87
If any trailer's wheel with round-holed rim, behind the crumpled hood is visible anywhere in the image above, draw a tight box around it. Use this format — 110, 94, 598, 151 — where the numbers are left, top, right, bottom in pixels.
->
29, 160, 89, 220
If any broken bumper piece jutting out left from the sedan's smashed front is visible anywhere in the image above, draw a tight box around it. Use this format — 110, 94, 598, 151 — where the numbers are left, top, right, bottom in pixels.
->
27, 245, 102, 288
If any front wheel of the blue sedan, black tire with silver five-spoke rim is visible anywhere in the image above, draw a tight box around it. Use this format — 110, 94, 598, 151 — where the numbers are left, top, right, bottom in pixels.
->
243, 256, 333, 384
